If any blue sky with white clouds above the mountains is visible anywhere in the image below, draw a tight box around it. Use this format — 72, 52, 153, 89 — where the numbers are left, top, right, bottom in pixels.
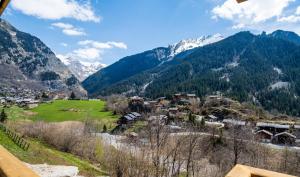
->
2, 0, 300, 65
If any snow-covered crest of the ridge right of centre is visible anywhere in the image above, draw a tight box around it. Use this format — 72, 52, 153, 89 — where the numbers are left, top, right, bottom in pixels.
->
169, 34, 224, 57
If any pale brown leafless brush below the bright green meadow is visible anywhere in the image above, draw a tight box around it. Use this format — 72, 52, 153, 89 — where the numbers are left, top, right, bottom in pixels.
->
15, 122, 97, 160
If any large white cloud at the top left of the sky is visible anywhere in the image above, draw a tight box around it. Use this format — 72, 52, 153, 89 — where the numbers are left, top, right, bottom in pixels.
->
11, 0, 101, 22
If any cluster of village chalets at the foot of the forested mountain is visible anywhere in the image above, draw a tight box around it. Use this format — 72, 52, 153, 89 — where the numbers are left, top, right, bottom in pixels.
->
118, 93, 300, 146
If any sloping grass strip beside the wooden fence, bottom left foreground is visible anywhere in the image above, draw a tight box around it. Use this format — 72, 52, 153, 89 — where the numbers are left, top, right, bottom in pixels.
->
0, 130, 106, 176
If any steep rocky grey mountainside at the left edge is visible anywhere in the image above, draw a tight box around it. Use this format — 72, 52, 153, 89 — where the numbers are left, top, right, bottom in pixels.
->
0, 19, 85, 94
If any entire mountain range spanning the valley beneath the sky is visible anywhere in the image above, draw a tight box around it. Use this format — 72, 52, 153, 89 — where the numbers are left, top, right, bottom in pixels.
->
0, 17, 300, 116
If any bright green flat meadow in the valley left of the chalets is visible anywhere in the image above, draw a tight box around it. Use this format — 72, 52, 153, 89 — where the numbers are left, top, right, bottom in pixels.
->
1, 100, 119, 127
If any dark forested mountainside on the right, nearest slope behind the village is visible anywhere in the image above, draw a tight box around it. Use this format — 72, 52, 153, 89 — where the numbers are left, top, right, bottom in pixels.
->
85, 31, 300, 116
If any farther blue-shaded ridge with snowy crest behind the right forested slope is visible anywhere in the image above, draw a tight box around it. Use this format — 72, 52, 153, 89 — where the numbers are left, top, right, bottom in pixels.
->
82, 34, 223, 96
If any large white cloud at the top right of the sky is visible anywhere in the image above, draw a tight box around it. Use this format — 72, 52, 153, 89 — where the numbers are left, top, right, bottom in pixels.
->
212, 0, 295, 28
